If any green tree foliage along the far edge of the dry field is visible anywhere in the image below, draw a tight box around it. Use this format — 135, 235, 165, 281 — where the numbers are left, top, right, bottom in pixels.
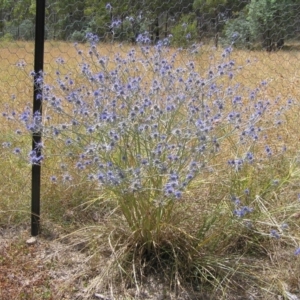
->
0, 0, 299, 50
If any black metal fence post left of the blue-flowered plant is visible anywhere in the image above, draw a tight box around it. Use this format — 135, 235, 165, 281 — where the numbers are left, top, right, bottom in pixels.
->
31, 0, 45, 236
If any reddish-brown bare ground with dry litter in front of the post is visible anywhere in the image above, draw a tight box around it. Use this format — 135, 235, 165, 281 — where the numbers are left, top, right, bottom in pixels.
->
0, 225, 300, 300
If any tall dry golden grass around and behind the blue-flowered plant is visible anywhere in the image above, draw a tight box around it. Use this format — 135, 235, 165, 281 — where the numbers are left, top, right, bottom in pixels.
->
0, 42, 300, 299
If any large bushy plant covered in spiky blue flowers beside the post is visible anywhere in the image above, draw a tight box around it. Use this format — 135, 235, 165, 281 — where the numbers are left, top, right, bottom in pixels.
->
3, 32, 290, 243
